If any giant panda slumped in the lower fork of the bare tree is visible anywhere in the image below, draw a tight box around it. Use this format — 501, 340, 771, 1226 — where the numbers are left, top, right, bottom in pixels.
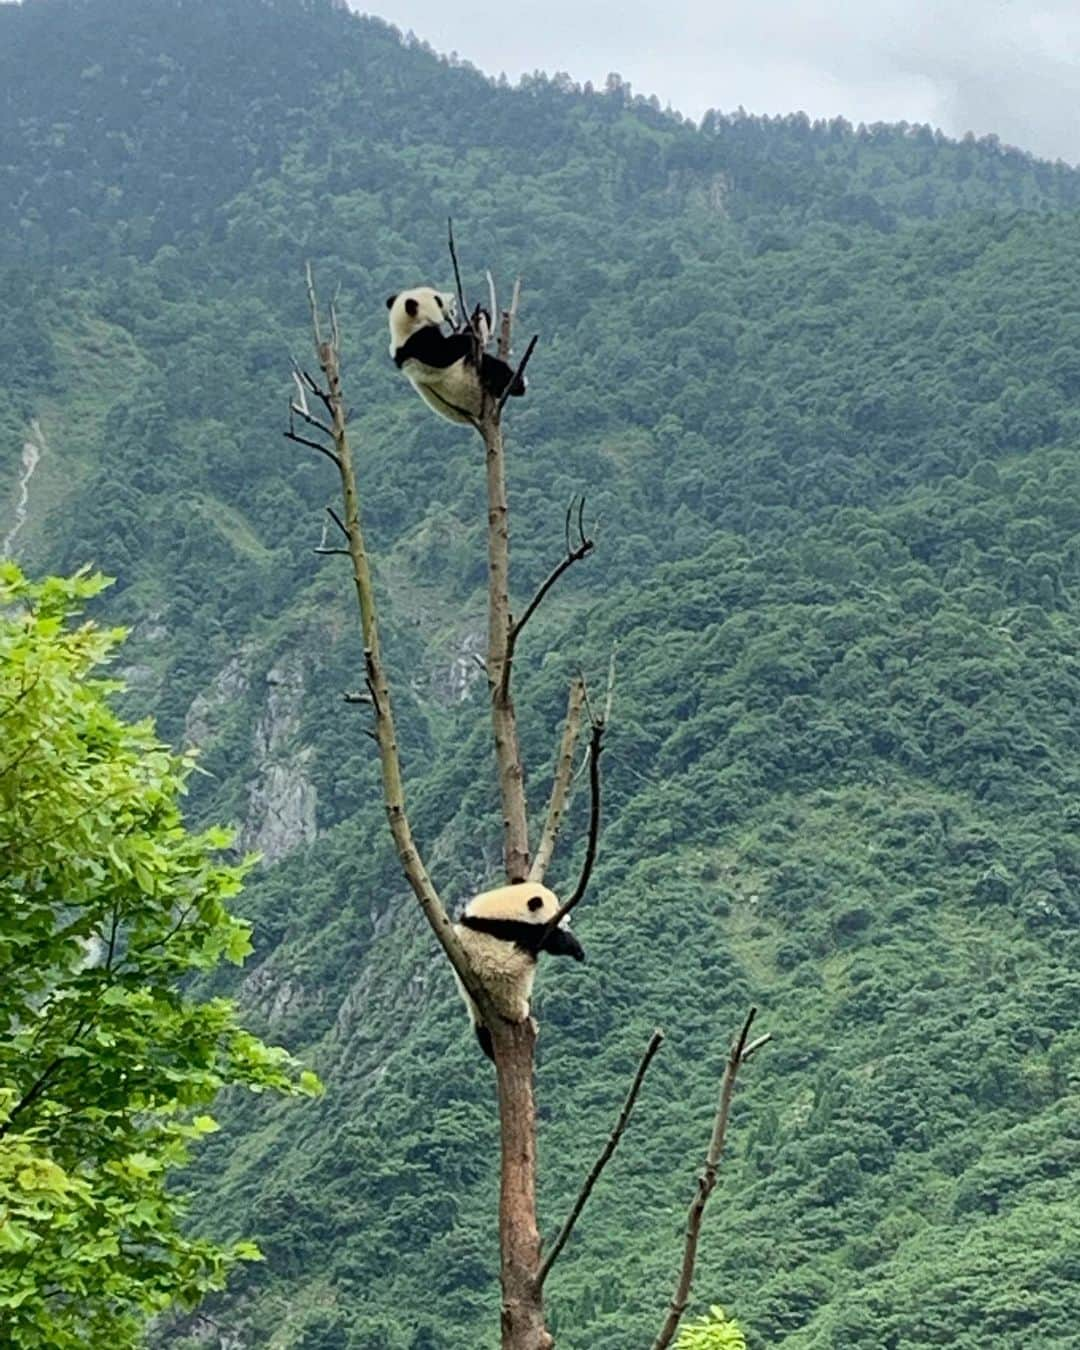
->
454, 882, 585, 1060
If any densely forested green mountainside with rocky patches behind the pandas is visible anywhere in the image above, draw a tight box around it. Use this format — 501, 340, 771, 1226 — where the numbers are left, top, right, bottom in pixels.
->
0, 0, 1080, 1350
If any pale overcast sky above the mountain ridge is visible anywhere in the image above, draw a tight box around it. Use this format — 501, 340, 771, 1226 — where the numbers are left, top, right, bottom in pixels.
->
351, 0, 1080, 163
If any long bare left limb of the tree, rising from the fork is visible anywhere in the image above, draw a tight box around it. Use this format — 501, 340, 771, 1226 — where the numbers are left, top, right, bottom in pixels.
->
286, 263, 494, 1018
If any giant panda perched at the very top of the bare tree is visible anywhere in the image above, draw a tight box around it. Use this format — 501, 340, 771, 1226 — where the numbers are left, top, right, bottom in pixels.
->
386, 286, 525, 424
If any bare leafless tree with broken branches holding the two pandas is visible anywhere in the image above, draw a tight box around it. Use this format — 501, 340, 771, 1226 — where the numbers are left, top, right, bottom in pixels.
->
285, 245, 761, 1350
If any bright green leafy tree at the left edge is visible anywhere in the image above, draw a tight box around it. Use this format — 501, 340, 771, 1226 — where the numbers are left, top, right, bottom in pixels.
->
0, 563, 319, 1350
